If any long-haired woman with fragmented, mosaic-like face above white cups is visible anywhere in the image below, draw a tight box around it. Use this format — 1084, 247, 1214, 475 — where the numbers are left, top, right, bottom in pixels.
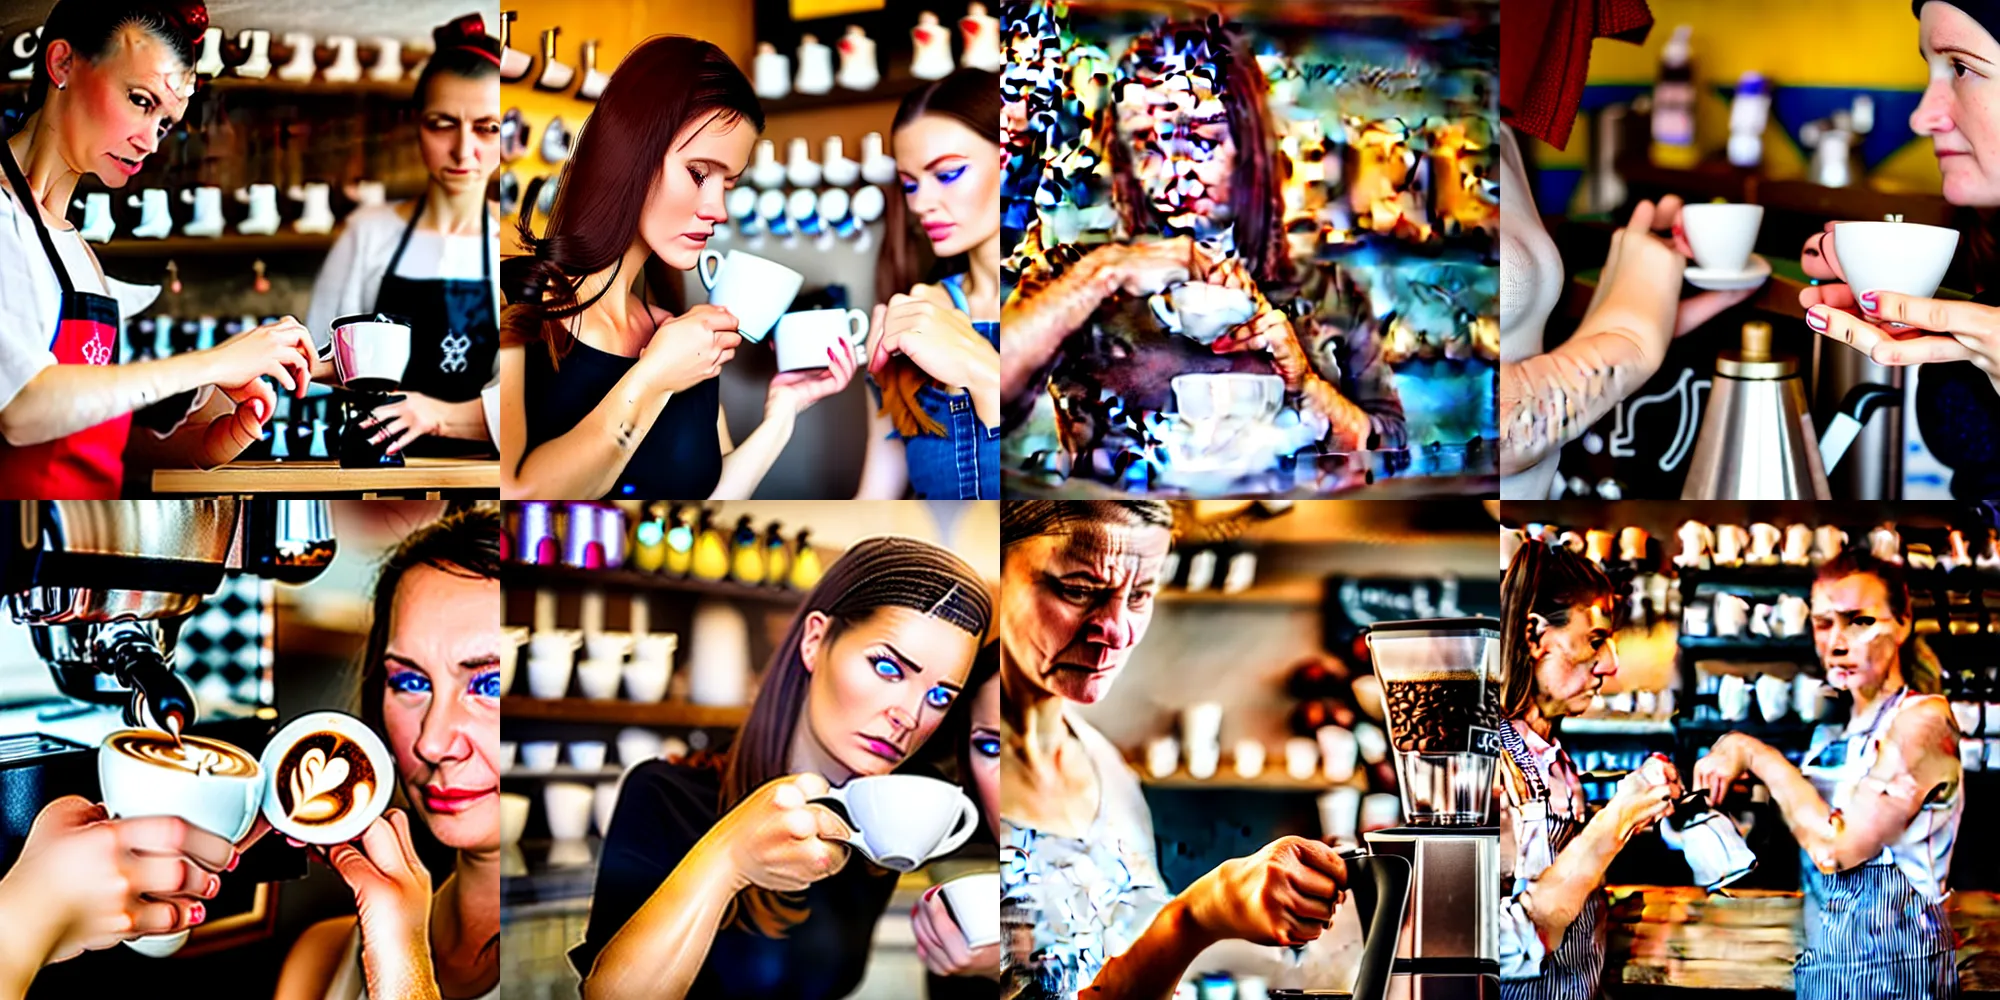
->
1000, 18, 1404, 480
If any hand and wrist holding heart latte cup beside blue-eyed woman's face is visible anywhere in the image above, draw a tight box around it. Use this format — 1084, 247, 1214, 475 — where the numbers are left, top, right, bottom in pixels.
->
326, 808, 438, 998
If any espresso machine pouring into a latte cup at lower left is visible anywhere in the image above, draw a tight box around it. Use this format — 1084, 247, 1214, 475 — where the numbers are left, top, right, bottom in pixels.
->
0, 496, 334, 870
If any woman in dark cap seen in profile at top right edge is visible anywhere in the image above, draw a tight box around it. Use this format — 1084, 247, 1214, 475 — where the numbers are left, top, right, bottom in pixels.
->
1798, 0, 2000, 500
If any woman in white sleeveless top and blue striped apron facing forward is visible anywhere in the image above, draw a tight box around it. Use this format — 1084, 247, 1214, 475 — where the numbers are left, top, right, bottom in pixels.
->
1694, 552, 1966, 1000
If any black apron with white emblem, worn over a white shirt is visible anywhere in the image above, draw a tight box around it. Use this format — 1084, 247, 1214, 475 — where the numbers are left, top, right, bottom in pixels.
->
374, 198, 500, 458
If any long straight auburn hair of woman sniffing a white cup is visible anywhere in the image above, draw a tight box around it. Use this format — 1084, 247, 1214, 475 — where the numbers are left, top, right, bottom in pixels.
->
500, 34, 764, 372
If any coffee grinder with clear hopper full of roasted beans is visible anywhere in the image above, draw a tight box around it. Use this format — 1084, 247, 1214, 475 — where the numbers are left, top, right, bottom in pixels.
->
1364, 618, 1504, 1000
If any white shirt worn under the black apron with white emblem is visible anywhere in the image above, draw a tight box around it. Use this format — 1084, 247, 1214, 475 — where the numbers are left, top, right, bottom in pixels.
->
308, 202, 500, 442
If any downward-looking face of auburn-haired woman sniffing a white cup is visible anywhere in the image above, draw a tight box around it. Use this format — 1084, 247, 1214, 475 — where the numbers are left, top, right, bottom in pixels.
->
638, 114, 756, 270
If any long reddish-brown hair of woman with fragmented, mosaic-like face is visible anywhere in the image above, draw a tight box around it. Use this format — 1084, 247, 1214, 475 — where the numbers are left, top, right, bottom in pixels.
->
1096, 14, 1290, 284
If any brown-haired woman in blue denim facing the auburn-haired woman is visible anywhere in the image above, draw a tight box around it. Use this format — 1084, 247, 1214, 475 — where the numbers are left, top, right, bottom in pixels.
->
856, 68, 1006, 500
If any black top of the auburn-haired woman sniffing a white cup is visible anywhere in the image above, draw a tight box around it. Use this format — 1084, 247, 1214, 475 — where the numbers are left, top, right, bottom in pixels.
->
526, 340, 722, 500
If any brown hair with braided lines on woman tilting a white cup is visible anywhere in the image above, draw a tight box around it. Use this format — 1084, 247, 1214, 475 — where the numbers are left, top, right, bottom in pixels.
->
720, 536, 992, 938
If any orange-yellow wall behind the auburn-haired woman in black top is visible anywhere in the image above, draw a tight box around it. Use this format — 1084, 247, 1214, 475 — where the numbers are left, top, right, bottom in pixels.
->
500, 0, 896, 254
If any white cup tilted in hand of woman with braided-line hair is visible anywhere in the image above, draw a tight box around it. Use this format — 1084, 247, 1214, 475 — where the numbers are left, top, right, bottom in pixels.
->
814, 774, 980, 872
